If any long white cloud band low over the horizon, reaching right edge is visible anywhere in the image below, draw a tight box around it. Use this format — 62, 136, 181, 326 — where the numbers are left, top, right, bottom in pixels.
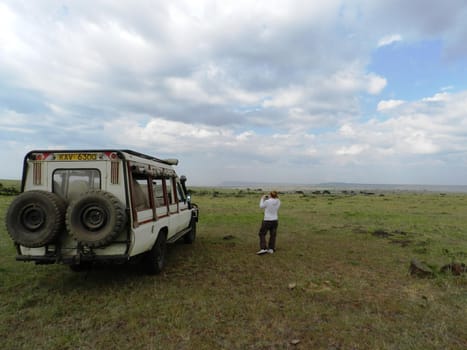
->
99, 88, 467, 169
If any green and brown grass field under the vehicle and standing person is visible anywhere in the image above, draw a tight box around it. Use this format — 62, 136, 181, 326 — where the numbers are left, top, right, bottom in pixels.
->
0, 190, 467, 349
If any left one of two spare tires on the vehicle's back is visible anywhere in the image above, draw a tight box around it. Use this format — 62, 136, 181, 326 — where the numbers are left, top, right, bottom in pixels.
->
6, 191, 65, 248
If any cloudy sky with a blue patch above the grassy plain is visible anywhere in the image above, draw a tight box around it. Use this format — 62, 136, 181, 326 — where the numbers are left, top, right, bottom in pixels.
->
0, 0, 467, 186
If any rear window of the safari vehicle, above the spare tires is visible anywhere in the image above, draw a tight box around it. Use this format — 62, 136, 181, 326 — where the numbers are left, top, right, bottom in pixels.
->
52, 169, 101, 199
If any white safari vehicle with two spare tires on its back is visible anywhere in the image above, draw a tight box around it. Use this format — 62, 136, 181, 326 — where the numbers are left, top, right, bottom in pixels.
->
6, 150, 198, 274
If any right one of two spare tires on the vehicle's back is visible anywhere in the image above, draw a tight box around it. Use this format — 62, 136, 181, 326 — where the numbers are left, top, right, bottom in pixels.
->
66, 190, 126, 248
